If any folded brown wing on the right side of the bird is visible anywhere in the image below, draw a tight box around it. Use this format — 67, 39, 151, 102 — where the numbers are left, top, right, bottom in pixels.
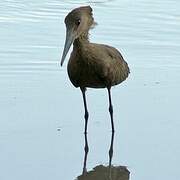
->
89, 44, 129, 84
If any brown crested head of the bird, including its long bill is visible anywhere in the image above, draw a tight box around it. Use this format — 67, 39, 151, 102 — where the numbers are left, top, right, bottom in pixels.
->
61, 6, 94, 66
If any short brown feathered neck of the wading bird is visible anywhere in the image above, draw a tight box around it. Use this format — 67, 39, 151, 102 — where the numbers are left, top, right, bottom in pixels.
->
73, 32, 89, 49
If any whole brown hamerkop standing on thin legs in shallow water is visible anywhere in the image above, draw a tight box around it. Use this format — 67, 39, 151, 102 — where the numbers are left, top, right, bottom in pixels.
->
61, 6, 130, 133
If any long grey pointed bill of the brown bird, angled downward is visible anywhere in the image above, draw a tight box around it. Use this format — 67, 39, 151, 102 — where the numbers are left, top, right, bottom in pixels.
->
61, 29, 75, 66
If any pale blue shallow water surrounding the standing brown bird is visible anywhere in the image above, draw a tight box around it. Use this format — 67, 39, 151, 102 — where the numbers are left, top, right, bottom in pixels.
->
0, 0, 180, 180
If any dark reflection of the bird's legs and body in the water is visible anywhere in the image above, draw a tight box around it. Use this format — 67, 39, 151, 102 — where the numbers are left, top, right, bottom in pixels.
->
77, 133, 130, 180
